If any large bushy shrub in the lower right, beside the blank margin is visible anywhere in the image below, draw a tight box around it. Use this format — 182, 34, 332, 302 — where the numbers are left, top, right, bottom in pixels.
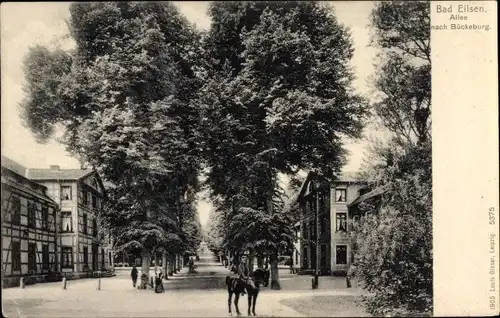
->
352, 143, 433, 316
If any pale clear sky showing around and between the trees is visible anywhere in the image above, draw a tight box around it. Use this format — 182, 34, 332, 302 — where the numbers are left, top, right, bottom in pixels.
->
0, 1, 376, 229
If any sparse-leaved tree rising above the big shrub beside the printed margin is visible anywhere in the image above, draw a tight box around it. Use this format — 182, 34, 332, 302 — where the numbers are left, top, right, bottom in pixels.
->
372, 1, 431, 144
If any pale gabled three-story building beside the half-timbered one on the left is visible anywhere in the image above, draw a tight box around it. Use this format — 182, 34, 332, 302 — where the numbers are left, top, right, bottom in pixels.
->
26, 166, 113, 278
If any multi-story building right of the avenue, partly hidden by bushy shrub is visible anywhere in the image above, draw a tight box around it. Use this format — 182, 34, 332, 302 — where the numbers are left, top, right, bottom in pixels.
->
297, 173, 367, 275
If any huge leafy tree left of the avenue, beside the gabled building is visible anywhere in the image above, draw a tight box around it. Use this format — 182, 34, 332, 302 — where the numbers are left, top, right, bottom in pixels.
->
21, 2, 202, 274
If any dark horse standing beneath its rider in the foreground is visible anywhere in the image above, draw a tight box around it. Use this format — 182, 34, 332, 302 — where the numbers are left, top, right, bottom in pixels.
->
226, 269, 269, 316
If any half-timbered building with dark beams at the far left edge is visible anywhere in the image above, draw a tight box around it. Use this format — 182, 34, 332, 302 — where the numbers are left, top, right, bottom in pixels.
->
2, 156, 60, 287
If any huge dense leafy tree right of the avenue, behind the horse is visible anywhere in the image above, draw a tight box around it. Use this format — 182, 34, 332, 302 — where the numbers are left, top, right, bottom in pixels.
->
200, 2, 364, 289
